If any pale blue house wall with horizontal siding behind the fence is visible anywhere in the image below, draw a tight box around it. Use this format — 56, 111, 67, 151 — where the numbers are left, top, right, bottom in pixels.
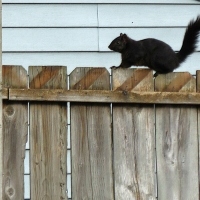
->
2, 0, 200, 199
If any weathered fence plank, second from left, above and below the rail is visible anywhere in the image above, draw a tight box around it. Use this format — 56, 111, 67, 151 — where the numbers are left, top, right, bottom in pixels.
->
29, 66, 67, 200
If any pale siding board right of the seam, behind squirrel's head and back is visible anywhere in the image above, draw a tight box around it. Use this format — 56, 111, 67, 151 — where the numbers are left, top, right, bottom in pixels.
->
99, 28, 200, 51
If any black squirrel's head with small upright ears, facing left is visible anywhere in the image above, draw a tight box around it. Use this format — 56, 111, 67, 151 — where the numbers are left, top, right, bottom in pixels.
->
108, 33, 128, 53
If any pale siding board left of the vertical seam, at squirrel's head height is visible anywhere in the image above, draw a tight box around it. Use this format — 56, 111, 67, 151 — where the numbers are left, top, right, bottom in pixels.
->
2, 28, 98, 51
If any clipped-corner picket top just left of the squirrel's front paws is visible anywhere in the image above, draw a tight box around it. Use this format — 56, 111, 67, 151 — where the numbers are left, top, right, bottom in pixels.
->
69, 67, 110, 90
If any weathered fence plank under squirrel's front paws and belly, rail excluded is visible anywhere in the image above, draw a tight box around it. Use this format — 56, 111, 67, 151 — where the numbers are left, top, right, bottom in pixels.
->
112, 69, 156, 200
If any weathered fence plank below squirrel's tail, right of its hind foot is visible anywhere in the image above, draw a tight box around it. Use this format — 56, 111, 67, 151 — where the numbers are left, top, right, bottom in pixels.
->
155, 73, 199, 200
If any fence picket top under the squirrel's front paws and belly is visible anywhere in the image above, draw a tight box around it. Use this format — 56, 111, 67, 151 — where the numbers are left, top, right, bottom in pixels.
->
112, 68, 154, 91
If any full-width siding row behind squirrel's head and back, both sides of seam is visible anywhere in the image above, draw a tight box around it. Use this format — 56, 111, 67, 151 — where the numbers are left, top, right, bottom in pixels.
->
2, 28, 200, 52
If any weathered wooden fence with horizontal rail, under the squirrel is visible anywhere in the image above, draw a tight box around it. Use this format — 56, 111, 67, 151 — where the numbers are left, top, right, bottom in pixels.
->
2, 66, 200, 200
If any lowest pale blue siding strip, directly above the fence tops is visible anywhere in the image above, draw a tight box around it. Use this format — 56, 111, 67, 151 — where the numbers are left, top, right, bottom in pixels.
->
2, 52, 200, 75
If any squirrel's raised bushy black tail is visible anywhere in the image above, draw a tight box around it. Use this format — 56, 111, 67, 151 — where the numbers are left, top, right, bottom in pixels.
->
177, 15, 200, 63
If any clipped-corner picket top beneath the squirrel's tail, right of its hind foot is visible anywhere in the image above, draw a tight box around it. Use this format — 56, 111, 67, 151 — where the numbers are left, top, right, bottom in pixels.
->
155, 72, 196, 92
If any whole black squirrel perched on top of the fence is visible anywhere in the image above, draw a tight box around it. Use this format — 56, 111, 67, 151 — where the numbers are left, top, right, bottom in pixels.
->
108, 15, 200, 77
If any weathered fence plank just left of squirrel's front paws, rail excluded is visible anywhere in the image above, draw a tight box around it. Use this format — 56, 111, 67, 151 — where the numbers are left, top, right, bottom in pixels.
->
70, 67, 114, 200
